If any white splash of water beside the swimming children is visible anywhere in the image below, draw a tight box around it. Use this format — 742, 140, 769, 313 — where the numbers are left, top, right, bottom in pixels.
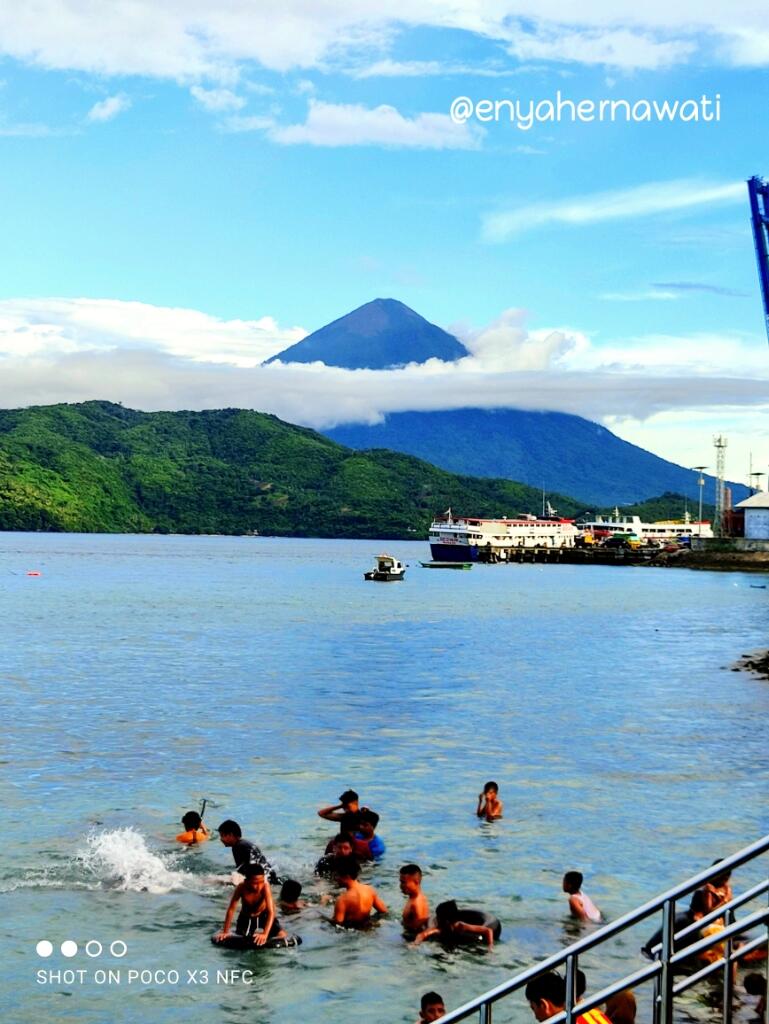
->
78, 827, 200, 893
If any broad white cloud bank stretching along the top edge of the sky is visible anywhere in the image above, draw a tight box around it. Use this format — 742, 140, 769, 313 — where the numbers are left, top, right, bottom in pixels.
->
0, 0, 769, 83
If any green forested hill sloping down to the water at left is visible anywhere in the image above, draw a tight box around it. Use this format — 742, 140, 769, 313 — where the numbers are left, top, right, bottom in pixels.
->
0, 401, 585, 538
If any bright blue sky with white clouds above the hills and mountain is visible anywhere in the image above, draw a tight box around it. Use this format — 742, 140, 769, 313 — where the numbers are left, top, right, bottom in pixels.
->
0, 0, 769, 476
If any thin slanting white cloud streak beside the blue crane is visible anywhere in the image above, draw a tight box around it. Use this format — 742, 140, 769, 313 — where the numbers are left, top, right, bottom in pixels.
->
482, 179, 745, 242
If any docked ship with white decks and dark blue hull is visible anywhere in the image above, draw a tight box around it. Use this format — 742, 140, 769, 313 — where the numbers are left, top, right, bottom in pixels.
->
429, 505, 580, 562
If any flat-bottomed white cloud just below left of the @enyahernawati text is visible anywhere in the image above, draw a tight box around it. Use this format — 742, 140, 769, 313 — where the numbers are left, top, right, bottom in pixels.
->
267, 98, 482, 150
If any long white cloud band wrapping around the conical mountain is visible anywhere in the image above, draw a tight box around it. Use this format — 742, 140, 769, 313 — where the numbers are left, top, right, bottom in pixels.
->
0, 299, 769, 456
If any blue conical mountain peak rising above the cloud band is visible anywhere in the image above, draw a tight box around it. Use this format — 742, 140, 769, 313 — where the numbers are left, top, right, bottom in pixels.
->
267, 299, 468, 370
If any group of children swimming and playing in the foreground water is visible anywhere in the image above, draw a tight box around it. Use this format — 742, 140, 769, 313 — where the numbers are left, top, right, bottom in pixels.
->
171, 781, 766, 1024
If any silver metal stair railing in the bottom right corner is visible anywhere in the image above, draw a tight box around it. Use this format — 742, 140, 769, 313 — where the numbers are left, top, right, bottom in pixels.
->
440, 836, 769, 1024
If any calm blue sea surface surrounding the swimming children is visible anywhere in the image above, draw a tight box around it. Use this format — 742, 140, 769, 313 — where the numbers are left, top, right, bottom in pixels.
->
0, 534, 769, 1024
